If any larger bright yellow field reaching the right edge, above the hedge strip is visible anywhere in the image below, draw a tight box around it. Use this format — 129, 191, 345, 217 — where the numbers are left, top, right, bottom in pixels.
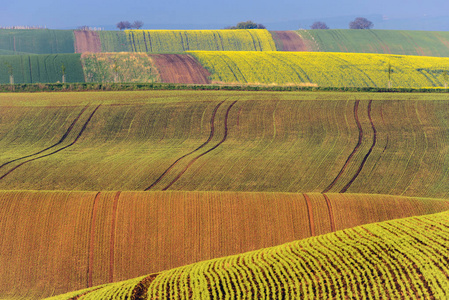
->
190, 51, 449, 88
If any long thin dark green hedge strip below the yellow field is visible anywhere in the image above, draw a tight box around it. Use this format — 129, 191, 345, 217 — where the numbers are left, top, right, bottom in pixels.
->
0, 83, 449, 93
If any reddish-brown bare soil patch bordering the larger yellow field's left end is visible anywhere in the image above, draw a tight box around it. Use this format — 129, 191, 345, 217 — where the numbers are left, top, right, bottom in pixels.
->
150, 54, 210, 84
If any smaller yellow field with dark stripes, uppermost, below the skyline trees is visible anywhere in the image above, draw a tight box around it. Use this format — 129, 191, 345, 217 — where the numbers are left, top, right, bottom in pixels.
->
126, 29, 276, 53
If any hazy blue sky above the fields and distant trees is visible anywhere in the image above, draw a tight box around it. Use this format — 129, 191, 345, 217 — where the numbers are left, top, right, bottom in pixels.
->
0, 0, 449, 30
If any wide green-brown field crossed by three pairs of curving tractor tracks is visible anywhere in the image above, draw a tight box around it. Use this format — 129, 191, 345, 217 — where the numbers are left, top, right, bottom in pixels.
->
0, 91, 449, 198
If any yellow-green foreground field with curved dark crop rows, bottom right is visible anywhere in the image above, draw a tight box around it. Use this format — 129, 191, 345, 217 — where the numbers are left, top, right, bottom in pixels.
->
46, 212, 449, 300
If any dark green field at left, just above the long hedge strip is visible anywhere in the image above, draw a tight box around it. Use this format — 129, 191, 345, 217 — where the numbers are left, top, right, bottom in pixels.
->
0, 54, 84, 84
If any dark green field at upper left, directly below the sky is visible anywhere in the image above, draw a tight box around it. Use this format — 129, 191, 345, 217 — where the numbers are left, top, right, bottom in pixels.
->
0, 29, 75, 54
